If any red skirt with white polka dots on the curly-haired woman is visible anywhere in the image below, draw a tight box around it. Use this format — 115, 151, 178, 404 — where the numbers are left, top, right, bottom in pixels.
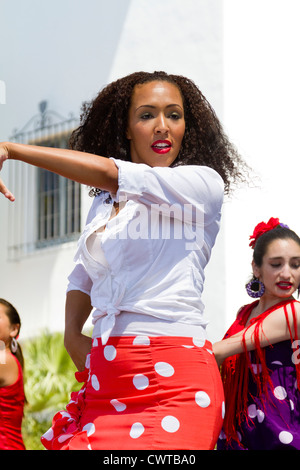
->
41, 336, 224, 450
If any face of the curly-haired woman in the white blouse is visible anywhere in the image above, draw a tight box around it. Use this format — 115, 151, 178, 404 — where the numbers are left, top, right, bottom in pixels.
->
127, 81, 185, 167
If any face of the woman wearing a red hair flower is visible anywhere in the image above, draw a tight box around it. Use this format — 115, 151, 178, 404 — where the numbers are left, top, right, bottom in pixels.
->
253, 239, 300, 299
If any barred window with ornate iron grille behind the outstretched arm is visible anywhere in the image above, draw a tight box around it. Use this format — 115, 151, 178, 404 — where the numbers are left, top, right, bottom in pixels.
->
8, 103, 81, 260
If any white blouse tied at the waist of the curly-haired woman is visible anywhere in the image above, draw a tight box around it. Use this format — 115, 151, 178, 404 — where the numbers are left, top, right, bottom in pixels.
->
67, 159, 224, 344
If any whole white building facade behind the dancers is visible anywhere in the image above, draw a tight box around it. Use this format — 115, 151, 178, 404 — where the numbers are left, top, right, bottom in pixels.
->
0, 0, 300, 341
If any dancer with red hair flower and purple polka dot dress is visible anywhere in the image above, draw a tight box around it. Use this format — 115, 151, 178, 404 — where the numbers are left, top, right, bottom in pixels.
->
213, 218, 300, 450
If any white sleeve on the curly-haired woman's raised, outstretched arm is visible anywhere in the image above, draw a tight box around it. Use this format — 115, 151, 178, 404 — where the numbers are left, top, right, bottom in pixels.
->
112, 158, 224, 225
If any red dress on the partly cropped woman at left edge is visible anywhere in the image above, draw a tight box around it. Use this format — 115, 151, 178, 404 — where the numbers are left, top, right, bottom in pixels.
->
0, 356, 25, 450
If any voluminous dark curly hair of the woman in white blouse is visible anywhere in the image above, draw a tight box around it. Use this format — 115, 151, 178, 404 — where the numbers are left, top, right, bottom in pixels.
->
69, 72, 248, 193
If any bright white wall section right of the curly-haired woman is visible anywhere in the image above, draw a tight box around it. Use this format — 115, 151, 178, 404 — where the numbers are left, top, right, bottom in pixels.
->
223, 0, 300, 325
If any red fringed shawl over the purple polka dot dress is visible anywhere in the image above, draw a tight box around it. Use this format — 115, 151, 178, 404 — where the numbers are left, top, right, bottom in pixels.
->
221, 299, 300, 443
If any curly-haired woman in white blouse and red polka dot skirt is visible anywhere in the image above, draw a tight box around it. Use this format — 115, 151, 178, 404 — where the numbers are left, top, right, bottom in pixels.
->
0, 72, 245, 449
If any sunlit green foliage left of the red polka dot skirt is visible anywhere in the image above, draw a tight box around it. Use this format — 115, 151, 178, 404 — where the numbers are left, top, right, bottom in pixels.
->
22, 332, 80, 450
